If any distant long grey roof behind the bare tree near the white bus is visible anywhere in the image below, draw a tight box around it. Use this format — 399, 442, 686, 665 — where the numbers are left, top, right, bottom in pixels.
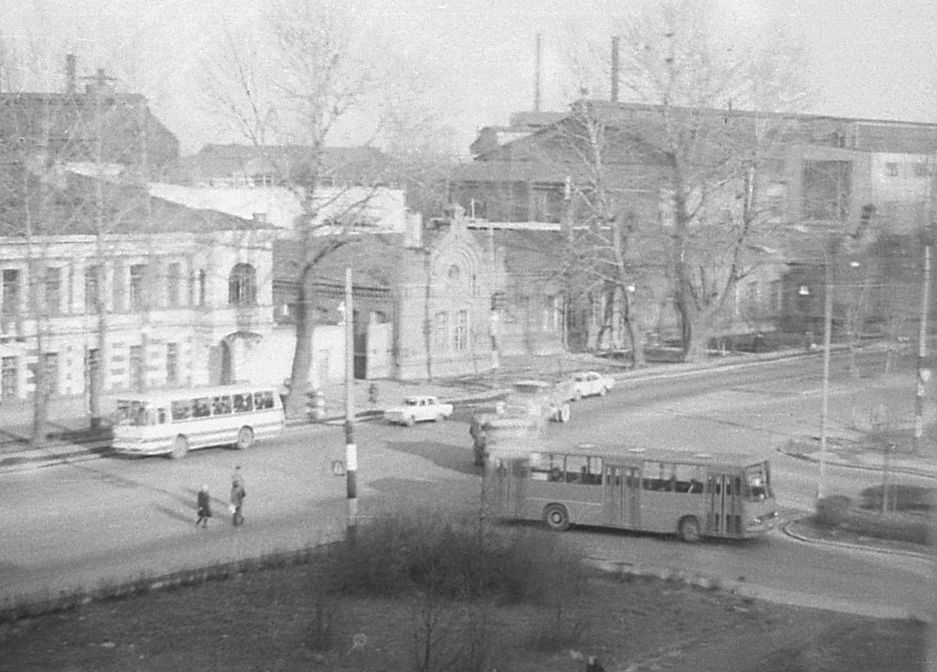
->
180, 144, 391, 184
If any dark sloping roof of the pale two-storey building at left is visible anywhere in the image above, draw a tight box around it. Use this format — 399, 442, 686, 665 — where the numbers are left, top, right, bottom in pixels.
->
0, 172, 273, 237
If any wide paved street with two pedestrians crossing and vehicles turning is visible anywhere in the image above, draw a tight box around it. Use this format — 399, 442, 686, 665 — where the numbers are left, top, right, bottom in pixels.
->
0, 352, 932, 613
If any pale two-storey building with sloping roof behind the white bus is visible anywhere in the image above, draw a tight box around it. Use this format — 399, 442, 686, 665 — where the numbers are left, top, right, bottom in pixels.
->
0, 174, 274, 404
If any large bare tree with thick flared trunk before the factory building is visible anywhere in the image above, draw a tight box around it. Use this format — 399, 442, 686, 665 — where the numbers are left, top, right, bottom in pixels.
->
564, 2, 804, 361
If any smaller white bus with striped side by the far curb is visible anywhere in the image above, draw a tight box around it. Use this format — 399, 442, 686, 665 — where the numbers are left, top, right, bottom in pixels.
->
112, 384, 283, 460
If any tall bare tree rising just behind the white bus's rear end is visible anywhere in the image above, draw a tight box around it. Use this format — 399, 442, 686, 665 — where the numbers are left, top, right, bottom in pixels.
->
201, 3, 410, 417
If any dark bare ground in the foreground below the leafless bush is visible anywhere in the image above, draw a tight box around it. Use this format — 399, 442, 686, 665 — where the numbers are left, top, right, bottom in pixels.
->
0, 566, 925, 672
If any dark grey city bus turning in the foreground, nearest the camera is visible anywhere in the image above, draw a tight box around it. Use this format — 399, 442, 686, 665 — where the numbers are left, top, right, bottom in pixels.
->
483, 445, 777, 542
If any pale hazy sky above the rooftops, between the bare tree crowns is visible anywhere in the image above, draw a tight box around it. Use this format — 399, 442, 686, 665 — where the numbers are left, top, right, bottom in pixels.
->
0, 0, 937, 153
